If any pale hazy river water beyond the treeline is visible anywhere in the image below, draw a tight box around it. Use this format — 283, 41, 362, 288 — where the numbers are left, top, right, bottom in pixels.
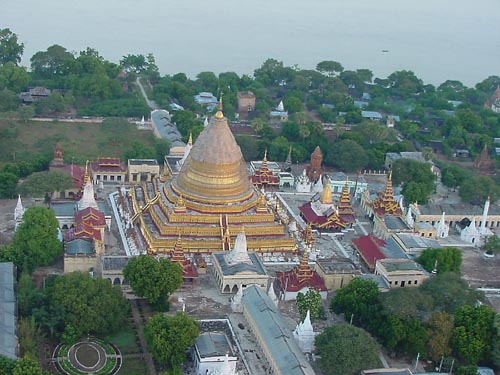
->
0, 0, 500, 86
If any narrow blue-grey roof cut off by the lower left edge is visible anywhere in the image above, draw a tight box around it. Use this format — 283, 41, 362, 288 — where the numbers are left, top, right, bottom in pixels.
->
0, 262, 17, 359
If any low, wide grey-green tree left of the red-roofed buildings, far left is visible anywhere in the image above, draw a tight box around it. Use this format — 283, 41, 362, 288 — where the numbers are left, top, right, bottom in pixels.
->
18, 171, 73, 197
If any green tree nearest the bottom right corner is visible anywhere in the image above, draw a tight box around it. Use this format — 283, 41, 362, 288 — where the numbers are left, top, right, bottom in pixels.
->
452, 305, 496, 365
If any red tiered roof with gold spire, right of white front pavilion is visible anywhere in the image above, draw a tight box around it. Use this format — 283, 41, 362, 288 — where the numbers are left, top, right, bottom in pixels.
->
276, 251, 327, 292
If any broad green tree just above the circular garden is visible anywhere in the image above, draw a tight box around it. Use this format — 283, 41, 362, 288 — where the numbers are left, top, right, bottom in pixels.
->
42, 272, 129, 336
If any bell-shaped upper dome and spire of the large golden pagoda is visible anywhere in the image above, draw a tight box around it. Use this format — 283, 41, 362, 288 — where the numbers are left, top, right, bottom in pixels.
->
171, 105, 257, 204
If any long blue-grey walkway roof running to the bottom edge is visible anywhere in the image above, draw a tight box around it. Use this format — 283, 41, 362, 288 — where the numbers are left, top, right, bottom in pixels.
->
243, 285, 314, 375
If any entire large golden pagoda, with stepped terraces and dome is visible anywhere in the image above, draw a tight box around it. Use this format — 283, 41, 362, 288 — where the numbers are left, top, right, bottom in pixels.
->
129, 103, 296, 254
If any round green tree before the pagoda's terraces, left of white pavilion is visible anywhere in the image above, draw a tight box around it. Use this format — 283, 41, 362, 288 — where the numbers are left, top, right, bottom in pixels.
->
123, 255, 182, 304
